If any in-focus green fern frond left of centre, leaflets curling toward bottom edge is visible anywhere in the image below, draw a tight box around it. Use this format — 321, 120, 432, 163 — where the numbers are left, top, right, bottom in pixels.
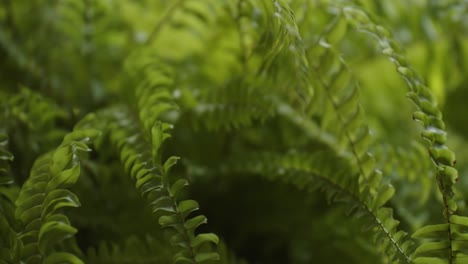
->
128, 55, 219, 263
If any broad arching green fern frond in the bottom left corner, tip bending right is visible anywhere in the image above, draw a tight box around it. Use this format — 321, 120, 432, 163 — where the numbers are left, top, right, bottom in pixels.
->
15, 120, 99, 263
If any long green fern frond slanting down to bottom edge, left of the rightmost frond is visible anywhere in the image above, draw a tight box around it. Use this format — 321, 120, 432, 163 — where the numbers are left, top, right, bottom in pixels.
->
254, 7, 410, 262
